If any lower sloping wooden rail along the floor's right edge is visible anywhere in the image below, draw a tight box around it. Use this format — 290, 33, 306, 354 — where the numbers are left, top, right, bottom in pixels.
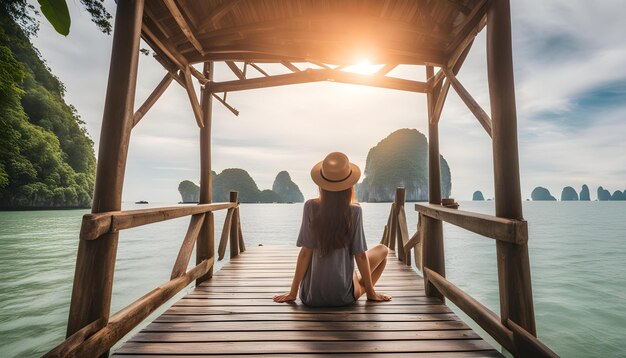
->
424, 266, 514, 352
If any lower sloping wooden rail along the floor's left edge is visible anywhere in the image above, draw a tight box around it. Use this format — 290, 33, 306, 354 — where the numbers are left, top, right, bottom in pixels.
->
46, 258, 214, 357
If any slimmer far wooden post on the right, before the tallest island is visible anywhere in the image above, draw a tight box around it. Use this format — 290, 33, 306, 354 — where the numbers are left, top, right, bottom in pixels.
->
422, 66, 446, 300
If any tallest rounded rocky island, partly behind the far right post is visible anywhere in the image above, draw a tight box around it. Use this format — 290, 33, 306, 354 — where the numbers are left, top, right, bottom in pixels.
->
356, 128, 452, 202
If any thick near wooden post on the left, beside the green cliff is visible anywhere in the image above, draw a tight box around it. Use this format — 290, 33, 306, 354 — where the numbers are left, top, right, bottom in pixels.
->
66, 0, 144, 355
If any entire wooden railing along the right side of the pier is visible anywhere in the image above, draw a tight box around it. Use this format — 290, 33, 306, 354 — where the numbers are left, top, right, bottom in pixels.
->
381, 188, 558, 357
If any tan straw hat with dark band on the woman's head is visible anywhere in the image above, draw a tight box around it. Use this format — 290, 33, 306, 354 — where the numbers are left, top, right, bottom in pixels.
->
311, 152, 361, 191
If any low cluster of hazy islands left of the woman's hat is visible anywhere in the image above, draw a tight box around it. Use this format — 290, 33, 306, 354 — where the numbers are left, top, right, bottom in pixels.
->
178, 168, 304, 203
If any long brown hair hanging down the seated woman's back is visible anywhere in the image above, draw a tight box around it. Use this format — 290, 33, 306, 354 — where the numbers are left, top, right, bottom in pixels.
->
311, 187, 354, 256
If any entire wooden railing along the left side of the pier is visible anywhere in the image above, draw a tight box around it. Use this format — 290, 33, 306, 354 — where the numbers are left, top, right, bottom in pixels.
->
44, 192, 245, 357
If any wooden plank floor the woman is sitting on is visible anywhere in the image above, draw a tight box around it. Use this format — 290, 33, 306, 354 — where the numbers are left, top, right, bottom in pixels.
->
114, 246, 502, 357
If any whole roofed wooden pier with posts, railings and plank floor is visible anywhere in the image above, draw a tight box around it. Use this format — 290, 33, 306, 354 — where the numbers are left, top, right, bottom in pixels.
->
46, 0, 556, 357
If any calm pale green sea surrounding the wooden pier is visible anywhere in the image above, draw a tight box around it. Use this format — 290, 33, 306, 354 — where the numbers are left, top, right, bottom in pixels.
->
0, 202, 626, 357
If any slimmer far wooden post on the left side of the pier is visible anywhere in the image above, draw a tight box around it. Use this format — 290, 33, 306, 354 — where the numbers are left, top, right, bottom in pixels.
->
196, 62, 215, 286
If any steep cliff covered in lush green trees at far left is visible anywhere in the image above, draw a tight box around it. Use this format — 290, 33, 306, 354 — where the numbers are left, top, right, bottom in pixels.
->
0, 8, 96, 208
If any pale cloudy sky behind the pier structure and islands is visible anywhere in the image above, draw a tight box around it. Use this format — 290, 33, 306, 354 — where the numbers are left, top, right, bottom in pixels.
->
32, 0, 626, 202
